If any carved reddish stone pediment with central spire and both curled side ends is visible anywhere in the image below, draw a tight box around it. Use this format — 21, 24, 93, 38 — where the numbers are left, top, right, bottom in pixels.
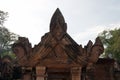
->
13, 9, 104, 66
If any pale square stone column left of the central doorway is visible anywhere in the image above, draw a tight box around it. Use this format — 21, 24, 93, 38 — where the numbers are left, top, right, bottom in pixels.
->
36, 66, 46, 80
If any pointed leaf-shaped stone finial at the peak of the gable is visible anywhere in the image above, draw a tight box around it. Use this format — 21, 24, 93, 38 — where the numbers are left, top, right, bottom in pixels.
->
50, 8, 67, 40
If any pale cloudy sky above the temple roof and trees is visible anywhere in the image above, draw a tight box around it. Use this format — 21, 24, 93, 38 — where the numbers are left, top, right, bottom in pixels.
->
0, 0, 120, 45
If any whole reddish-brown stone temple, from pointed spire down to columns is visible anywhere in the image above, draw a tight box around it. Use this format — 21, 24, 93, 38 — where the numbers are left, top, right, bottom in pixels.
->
12, 8, 117, 80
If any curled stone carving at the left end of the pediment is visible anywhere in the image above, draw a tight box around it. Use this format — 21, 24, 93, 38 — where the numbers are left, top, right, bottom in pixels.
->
12, 37, 32, 66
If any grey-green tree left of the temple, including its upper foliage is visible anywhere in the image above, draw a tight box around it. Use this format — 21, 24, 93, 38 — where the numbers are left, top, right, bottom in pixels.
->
0, 11, 18, 56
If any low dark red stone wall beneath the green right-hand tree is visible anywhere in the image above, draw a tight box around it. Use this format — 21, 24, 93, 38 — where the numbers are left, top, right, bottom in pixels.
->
94, 59, 114, 80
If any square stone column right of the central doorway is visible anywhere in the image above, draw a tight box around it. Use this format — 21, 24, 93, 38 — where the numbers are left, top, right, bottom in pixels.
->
71, 67, 82, 80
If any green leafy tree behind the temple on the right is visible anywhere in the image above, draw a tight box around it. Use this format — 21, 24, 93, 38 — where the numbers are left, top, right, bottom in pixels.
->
99, 28, 120, 62
